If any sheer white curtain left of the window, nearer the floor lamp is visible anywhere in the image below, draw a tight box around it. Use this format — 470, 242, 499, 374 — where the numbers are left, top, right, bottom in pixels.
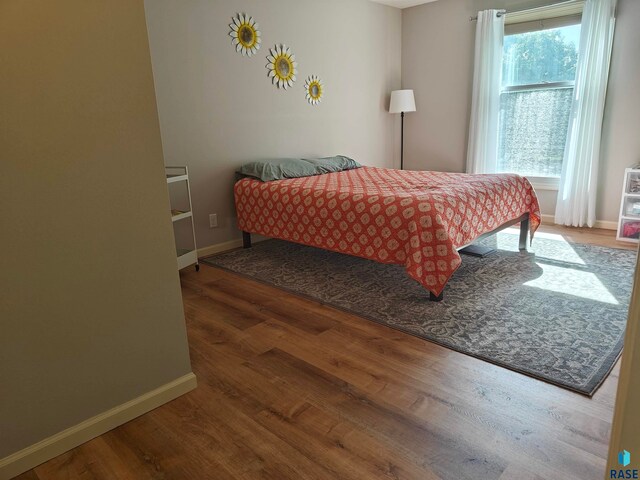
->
467, 10, 504, 173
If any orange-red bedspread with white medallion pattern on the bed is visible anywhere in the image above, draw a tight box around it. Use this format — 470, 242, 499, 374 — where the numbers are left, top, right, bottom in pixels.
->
234, 167, 540, 295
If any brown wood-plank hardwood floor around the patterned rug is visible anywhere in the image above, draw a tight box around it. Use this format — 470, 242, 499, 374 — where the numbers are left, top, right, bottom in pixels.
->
17, 227, 635, 480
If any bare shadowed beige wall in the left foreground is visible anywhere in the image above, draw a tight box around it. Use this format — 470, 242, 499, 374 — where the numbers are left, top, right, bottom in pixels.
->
0, 0, 191, 459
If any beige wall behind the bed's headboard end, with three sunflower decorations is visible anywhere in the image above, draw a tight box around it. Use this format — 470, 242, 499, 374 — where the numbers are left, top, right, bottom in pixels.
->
145, 0, 401, 247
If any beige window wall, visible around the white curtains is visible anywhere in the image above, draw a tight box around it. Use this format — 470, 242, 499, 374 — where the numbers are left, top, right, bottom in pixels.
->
402, 0, 640, 221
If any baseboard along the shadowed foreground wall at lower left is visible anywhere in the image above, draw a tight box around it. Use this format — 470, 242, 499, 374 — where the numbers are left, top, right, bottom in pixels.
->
0, 373, 197, 480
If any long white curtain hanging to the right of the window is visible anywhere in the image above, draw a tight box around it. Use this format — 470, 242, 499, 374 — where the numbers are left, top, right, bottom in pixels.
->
555, 0, 617, 227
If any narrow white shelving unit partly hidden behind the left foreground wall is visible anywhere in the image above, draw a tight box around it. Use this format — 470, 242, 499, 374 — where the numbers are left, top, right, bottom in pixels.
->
165, 166, 200, 271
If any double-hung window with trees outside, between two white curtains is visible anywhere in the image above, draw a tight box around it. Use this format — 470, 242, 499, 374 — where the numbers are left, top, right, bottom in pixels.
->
498, 11, 580, 188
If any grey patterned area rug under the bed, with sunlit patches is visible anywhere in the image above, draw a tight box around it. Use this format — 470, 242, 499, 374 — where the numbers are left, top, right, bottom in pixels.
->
204, 230, 636, 396
